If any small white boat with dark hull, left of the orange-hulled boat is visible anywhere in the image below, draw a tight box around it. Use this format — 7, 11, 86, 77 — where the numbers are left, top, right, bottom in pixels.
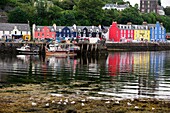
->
16, 44, 39, 55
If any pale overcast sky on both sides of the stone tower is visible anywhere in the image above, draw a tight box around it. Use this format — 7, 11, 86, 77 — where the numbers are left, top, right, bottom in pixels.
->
125, 0, 170, 7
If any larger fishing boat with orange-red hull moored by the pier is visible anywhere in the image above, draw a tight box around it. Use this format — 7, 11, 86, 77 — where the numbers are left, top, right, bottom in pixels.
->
45, 43, 80, 57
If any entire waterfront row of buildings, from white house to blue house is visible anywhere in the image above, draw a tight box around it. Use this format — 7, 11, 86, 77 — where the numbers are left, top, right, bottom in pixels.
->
0, 22, 166, 42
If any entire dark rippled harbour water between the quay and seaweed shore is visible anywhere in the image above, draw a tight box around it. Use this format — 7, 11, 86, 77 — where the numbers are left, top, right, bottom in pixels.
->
0, 51, 170, 99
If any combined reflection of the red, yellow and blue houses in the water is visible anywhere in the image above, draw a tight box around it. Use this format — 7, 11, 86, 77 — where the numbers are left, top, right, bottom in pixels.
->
107, 52, 166, 97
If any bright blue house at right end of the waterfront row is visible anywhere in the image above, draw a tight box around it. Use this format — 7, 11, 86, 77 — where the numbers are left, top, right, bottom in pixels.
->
148, 22, 166, 42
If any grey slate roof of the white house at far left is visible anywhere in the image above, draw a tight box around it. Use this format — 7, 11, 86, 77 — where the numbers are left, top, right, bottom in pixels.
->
0, 23, 30, 31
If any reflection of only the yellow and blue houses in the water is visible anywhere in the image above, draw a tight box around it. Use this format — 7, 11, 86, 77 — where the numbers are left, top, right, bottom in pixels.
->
134, 52, 165, 96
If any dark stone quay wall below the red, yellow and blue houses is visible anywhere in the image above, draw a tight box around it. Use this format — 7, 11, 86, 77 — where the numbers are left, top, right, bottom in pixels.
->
106, 43, 170, 51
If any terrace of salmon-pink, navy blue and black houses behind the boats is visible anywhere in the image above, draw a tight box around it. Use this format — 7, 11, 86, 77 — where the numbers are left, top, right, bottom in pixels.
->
32, 24, 102, 40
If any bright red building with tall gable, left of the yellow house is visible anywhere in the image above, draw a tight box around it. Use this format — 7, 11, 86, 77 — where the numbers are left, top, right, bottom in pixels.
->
109, 22, 134, 42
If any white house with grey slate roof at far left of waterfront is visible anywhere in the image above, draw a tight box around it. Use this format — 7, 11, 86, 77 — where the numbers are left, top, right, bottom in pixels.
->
0, 23, 31, 41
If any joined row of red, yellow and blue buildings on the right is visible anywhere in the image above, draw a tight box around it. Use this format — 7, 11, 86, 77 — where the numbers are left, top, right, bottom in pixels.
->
109, 22, 166, 42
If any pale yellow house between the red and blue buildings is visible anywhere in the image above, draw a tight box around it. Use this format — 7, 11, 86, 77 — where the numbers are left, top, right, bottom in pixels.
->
134, 25, 150, 41
